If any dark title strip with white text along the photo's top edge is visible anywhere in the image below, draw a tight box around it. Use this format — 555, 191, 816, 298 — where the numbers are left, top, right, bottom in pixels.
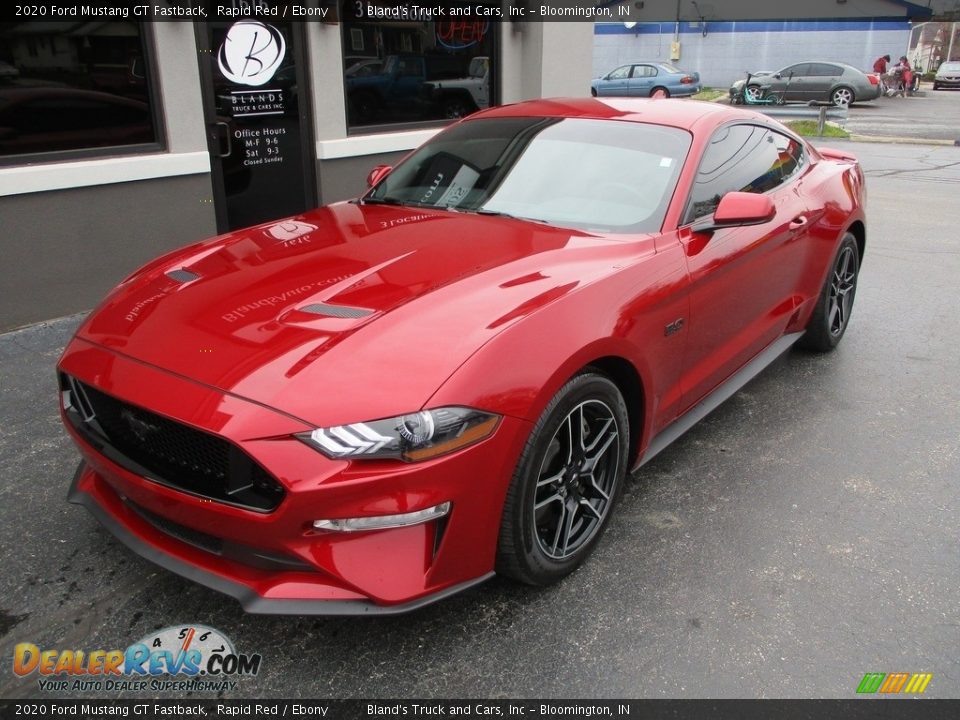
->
0, 0, 922, 25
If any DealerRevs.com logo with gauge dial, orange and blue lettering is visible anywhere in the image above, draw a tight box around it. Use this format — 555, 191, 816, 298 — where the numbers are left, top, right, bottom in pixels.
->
13, 625, 262, 692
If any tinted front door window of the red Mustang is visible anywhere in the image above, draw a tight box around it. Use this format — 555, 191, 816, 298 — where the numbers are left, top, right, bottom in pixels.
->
686, 125, 783, 222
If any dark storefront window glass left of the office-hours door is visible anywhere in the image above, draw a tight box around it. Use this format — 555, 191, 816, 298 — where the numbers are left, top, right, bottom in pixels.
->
0, 21, 157, 158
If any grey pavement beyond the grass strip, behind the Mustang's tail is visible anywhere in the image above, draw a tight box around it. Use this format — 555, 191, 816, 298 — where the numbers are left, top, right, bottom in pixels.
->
845, 83, 960, 142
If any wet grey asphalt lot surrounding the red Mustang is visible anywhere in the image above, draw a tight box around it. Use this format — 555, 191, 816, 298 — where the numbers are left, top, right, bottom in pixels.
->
0, 138, 960, 698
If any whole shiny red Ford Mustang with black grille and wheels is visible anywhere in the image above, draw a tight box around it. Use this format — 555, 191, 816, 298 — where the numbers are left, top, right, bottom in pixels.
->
59, 98, 865, 614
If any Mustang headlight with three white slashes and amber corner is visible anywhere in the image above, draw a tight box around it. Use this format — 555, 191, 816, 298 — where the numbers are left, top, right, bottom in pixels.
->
296, 407, 500, 462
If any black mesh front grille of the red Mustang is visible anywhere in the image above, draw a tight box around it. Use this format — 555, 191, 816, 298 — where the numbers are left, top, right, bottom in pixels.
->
61, 375, 284, 512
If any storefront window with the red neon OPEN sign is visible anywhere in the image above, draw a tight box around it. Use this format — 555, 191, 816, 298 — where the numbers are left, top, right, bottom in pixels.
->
341, 2, 500, 130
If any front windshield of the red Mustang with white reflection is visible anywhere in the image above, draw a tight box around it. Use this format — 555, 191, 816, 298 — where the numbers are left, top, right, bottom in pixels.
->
364, 117, 690, 232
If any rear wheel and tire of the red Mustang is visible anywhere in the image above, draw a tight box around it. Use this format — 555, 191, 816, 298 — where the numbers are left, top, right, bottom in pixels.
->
798, 233, 860, 352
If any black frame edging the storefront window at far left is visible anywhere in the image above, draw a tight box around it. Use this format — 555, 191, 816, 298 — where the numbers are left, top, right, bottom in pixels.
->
0, 22, 169, 170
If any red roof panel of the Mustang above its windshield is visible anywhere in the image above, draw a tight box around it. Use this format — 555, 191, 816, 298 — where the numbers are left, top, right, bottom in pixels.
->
471, 97, 766, 130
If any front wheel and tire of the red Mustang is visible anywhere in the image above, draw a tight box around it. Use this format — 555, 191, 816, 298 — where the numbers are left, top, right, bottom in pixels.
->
496, 370, 630, 585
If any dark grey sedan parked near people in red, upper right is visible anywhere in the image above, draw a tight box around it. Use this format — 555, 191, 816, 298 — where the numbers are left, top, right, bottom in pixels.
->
730, 61, 880, 105
